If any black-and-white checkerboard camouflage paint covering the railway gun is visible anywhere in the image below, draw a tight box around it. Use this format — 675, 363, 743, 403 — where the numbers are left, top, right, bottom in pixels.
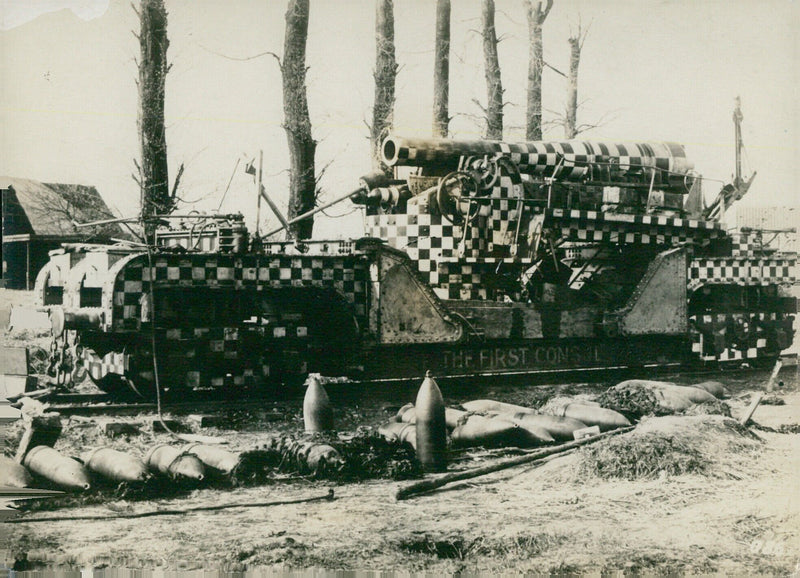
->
36, 138, 798, 390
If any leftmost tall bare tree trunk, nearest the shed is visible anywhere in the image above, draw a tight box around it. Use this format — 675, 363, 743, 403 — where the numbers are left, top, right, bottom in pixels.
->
139, 0, 173, 242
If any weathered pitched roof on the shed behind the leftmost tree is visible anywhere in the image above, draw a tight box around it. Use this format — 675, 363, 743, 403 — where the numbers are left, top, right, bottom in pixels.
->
0, 177, 128, 238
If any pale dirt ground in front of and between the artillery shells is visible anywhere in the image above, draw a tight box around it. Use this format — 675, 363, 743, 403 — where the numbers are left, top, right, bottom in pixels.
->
0, 288, 800, 575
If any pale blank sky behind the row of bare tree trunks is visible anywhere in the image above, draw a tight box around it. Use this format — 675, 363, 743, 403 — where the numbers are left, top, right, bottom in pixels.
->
0, 0, 800, 238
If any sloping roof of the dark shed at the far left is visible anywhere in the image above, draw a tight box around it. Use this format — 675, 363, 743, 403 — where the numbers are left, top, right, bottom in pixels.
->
0, 177, 129, 240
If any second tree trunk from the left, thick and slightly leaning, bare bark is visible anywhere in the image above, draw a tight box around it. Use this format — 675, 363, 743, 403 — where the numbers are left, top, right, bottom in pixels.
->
281, 0, 317, 239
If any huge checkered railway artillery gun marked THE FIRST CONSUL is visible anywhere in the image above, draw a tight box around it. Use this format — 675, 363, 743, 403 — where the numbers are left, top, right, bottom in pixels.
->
29, 127, 797, 397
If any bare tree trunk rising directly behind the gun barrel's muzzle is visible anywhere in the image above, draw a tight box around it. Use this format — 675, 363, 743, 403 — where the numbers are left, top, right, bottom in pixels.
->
370, 0, 397, 175
